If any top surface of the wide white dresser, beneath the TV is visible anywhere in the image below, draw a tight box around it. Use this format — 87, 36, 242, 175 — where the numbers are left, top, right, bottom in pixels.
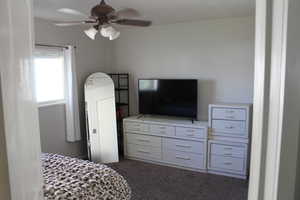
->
124, 115, 208, 128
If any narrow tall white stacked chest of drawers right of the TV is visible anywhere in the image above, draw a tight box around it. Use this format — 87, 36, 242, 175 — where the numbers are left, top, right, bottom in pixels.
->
207, 104, 252, 178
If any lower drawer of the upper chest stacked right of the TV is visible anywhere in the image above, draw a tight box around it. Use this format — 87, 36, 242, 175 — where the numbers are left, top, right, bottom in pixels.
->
212, 120, 247, 136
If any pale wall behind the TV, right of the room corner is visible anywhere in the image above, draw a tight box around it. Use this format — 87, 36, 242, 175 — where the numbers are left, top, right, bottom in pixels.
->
112, 17, 254, 119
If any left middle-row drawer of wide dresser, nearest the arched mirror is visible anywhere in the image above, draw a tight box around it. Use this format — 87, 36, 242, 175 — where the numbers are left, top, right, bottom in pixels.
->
126, 133, 161, 147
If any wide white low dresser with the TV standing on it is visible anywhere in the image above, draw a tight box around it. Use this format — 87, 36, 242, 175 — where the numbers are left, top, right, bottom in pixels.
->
124, 116, 208, 171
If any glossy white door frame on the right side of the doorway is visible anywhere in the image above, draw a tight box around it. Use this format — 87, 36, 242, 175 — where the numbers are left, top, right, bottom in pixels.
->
248, 0, 289, 200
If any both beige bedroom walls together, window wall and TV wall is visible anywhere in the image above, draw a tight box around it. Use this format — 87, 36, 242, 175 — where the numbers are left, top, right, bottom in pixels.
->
35, 17, 254, 156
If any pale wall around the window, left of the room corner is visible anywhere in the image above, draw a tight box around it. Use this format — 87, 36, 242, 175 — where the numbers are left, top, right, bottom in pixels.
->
35, 18, 111, 156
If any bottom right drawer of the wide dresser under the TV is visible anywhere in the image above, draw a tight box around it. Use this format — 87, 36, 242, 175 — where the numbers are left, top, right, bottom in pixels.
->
163, 151, 205, 169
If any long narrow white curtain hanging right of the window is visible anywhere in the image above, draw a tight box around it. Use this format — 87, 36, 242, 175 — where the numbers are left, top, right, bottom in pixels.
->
64, 46, 81, 142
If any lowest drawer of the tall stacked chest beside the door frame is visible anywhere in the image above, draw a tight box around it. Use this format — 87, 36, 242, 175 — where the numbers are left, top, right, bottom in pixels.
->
209, 155, 245, 173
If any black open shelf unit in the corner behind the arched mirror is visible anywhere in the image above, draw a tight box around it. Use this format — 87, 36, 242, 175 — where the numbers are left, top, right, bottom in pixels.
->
108, 73, 129, 156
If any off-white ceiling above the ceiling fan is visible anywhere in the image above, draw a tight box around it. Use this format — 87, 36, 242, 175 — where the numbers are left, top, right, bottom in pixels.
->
34, 0, 255, 24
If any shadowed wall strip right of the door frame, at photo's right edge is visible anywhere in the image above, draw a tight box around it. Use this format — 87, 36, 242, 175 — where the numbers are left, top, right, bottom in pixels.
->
278, 0, 300, 200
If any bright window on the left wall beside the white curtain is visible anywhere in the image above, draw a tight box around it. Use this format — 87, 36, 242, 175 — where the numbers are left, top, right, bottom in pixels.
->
34, 48, 66, 104
